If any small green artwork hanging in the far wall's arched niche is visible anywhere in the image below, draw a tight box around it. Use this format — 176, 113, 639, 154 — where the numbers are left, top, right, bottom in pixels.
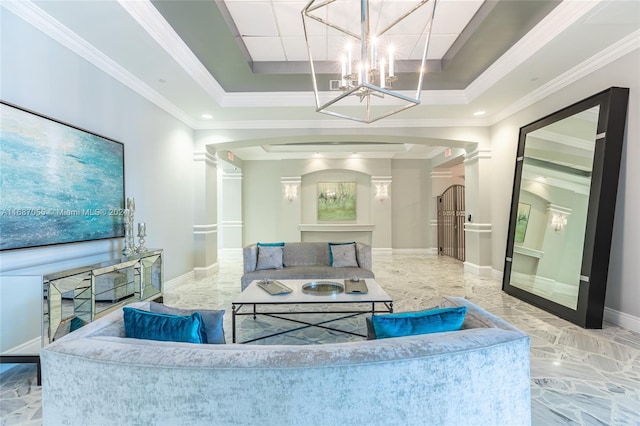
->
318, 182, 356, 220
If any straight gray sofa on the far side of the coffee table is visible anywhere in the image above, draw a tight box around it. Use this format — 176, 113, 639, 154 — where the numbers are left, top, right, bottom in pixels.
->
241, 242, 375, 290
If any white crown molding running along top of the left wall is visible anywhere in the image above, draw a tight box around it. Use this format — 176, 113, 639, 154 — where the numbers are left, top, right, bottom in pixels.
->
2, 0, 195, 127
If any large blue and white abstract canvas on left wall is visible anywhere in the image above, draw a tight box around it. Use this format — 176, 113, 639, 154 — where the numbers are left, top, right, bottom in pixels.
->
0, 102, 124, 250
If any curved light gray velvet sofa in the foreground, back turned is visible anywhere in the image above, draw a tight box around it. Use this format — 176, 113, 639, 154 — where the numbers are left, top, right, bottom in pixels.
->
41, 298, 531, 426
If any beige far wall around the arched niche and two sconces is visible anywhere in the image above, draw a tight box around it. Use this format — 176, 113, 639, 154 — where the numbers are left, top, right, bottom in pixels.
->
242, 159, 435, 249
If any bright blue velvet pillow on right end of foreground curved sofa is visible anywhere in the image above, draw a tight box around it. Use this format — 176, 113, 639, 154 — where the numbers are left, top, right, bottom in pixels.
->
367, 306, 467, 339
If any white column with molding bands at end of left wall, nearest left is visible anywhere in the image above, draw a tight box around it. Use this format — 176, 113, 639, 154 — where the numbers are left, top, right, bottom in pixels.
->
193, 151, 218, 278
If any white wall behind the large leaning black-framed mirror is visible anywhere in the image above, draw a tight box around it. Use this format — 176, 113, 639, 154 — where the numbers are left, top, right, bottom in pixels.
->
491, 50, 640, 322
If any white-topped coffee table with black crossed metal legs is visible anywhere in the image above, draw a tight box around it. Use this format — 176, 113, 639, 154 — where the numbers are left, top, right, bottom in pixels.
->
231, 278, 393, 343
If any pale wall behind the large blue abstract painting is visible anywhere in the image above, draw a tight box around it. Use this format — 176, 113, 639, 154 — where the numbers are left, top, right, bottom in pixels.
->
0, 9, 193, 279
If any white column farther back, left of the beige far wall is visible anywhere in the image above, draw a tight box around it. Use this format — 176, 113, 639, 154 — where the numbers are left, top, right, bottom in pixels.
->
220, 169, 244, 250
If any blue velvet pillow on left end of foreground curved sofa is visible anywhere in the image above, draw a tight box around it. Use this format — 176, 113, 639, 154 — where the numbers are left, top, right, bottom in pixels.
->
122, 306, 207, 343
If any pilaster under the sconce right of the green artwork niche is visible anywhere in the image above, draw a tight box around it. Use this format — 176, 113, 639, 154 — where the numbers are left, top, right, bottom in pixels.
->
371, 176, 393, 251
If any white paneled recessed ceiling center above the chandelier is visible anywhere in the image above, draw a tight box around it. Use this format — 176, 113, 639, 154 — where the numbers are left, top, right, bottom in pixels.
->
224, 0, 484, 62
